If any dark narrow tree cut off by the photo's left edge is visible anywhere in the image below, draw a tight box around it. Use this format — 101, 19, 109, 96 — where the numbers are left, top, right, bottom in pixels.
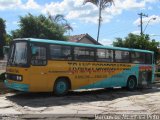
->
0, 18, 6, 59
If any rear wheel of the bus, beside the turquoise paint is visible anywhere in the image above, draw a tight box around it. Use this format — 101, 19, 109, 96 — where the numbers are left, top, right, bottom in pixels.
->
127, 76, 137, 91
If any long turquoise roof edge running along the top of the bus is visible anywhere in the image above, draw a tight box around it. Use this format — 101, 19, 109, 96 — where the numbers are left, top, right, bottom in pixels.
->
14, 38, 154, 54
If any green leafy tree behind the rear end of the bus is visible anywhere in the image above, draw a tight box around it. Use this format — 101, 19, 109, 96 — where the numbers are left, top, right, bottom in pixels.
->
113, 33, 159, 60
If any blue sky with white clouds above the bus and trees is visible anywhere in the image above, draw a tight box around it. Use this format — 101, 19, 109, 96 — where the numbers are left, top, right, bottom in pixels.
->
0, 0, 160, 45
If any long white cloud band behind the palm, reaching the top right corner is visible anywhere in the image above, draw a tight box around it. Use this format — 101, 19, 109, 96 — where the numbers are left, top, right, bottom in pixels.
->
42, 0, 157, 23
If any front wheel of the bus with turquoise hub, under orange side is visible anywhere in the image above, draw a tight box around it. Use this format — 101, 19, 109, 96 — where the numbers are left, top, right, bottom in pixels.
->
53, 78, 69, 96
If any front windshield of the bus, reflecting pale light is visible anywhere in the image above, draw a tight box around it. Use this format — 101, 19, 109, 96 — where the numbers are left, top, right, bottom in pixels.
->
8, 42, 27, 66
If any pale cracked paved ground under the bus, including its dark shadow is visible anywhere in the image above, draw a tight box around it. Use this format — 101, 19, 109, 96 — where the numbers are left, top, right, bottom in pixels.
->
0, 86, 160, 120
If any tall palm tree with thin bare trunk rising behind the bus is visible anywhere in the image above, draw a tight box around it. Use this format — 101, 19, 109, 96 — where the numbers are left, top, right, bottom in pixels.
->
84, 0, 114, 42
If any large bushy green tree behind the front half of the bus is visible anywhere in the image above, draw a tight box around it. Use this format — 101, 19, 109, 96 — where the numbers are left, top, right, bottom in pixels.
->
12, 13, 66, 40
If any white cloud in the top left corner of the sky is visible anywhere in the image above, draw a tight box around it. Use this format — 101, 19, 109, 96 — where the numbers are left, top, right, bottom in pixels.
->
0, 0, 40, 10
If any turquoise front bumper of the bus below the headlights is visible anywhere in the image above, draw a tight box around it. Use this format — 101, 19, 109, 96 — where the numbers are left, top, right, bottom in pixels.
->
4, 80, 29, 92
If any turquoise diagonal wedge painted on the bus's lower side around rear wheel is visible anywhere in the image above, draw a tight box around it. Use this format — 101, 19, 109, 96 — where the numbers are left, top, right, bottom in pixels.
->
79, 65, 139, 89
